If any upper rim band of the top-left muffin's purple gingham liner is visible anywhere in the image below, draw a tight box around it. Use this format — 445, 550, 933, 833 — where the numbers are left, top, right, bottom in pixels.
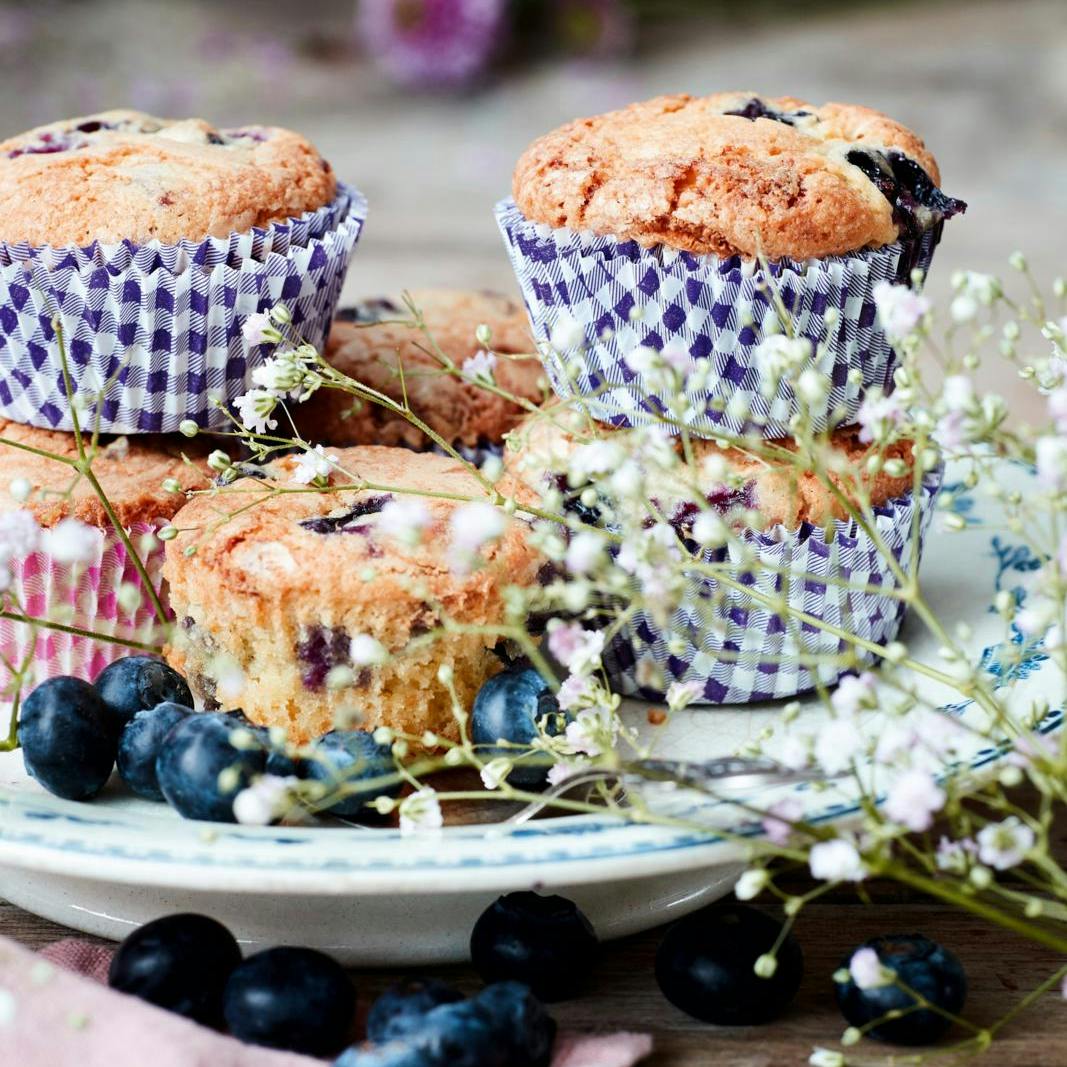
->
0, 182, 367, 274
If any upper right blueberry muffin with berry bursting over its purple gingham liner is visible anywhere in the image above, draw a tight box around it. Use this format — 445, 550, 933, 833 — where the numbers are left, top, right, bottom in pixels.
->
496, 93, 966, 439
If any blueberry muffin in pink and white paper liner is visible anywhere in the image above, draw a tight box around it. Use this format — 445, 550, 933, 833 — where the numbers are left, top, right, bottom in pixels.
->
0, 419, 210, 702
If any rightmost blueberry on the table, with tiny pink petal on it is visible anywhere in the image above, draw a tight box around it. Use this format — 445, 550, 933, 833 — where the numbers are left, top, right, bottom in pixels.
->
837, 934, 967, 1045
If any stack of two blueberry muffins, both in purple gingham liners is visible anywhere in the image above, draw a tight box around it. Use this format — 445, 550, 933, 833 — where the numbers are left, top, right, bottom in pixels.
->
497, 93, 965, 703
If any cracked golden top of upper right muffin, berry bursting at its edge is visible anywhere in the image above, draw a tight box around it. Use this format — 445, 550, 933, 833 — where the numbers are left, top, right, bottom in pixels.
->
513, 93, 966, 259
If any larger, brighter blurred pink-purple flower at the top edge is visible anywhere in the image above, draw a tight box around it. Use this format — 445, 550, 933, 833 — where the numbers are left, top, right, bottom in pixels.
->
356, 0, 509, 89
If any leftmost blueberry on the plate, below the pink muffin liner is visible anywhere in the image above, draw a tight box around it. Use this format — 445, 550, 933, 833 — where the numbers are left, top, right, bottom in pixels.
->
18, 678, 121, 800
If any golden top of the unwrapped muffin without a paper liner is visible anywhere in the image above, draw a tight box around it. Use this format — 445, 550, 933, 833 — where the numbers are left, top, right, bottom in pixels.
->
164, 447, 536, 625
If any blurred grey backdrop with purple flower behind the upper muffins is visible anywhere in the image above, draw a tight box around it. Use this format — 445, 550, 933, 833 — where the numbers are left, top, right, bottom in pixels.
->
0, 0, 1067, 409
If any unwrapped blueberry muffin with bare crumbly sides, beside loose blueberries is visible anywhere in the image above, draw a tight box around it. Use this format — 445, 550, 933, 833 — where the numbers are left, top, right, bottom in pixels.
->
164, 447, 538, 742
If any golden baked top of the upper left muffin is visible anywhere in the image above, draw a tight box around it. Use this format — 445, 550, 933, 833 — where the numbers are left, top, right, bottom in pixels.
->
0, 111, 336, 246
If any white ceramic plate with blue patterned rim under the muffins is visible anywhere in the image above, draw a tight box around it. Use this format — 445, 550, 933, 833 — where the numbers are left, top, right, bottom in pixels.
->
0, 468, 1064, 965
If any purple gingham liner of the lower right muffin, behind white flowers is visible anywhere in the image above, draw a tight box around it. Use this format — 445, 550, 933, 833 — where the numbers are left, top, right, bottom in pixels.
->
604, 469, 942, 704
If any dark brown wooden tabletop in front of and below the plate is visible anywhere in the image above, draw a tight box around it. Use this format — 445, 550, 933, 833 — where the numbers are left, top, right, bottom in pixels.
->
0, 810, 1067, 1067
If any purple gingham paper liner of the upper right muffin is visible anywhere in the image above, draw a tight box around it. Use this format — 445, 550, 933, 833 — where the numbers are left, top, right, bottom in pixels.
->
496, 198, 941, 437
